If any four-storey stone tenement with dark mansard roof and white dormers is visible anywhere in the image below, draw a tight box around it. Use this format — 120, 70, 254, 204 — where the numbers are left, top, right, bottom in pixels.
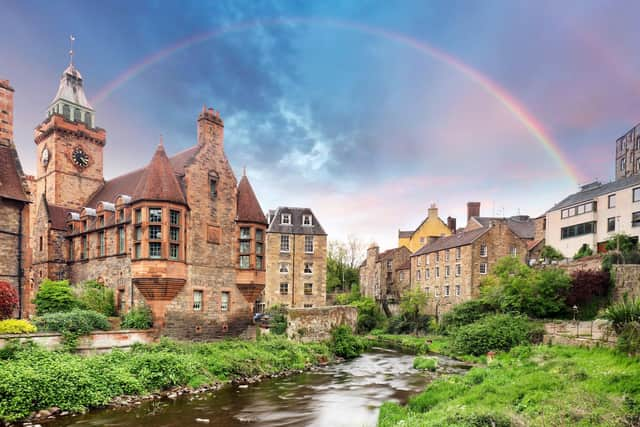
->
261, 207, 327, 308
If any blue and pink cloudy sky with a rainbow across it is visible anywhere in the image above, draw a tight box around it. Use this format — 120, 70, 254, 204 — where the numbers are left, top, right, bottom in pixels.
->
0, 0, 640, 248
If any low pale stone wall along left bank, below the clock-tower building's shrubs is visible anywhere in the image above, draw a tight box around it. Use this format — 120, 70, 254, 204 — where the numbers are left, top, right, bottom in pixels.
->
0, 330, 155, 354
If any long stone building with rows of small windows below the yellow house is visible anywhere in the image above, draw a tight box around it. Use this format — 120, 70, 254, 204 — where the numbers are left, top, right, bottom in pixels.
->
411, 203, 536, 316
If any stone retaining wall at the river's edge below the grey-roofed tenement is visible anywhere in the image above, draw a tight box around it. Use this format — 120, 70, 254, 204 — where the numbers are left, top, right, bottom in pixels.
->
287, 305, 358, 342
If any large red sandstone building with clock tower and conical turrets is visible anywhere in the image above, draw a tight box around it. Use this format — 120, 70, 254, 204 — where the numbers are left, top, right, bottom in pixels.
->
18, 57, 267, 339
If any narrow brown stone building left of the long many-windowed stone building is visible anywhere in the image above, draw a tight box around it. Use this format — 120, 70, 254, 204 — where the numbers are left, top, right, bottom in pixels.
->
360, 244, 411, 307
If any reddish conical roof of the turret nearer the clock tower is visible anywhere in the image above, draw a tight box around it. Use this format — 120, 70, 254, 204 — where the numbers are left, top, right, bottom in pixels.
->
133, 144, 187, 205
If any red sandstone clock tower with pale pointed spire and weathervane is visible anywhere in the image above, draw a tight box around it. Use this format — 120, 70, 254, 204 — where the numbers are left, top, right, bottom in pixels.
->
34, 51, 106, 209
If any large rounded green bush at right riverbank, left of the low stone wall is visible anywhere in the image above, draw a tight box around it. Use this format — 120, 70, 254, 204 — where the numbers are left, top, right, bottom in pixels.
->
451, 314, 541, 356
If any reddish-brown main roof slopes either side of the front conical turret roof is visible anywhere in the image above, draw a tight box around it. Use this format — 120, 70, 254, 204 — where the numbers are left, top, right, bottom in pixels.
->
87, 145, 199, 208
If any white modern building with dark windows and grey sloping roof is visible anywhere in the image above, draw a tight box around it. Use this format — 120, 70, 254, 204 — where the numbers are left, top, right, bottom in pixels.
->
545, 175, 640, 257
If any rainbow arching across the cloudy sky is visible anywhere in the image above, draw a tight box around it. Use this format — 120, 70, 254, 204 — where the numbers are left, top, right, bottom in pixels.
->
91, 17, 582, 183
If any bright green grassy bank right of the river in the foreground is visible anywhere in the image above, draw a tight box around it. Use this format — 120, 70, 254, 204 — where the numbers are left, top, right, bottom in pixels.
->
379, 346, 640, 427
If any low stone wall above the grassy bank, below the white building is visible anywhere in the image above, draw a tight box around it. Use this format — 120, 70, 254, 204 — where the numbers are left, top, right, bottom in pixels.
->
543, 320, 617, 347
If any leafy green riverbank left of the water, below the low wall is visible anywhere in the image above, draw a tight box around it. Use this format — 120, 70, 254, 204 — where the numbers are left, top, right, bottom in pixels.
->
0, 336, 335, 422
